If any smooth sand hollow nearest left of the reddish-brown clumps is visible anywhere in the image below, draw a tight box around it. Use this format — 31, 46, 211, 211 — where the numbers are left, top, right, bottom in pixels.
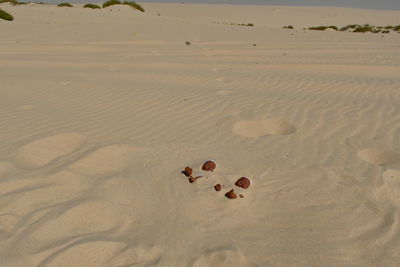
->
69, 145, 140, 176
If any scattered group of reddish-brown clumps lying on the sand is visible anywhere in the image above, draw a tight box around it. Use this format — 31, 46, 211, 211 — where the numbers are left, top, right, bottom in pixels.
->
182, 160, 251, 199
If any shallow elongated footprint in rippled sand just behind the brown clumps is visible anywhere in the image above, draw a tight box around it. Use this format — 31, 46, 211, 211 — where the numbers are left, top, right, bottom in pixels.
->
232, 119, 296, 137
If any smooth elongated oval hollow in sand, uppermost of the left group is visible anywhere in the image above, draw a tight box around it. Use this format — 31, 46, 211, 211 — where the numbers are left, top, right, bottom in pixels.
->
15, 133, 87, 169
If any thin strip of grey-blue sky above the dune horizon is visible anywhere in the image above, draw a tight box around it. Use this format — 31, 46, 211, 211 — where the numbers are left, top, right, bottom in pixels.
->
57, 0, 400, 10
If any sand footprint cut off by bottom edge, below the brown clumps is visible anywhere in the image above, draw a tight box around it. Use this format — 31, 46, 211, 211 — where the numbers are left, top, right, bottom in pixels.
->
193, 250, 256, 267
